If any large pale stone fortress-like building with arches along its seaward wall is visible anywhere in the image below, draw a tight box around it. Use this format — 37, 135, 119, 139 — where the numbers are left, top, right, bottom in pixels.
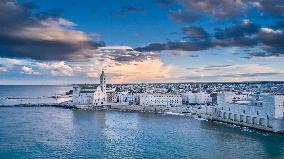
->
213, 92, 284, 132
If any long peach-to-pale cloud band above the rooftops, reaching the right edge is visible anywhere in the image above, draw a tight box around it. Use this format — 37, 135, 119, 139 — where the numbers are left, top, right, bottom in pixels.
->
75, 47, 284, 83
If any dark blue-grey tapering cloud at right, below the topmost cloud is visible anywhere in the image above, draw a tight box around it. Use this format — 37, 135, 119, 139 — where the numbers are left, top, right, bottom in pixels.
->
135, 19, 284, 58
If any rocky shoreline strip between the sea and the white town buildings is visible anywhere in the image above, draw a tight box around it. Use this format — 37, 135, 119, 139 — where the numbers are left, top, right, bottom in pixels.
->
0, 103, 283, 134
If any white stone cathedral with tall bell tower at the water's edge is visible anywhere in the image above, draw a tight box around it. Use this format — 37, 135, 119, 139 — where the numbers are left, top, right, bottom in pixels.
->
72, 71, 107, 106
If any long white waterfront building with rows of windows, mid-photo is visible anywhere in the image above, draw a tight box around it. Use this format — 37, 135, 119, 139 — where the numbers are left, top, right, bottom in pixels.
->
139, 93, 182, 106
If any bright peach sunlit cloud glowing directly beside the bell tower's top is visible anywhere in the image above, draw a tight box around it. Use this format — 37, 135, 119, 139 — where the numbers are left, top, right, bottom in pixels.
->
88, 59, 172, 83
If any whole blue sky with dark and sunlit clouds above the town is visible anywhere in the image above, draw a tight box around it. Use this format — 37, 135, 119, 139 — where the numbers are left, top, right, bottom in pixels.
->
0, 0, 284, 85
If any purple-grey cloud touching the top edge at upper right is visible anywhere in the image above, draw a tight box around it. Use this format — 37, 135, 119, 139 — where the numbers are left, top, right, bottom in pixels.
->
161, 0, 284, 22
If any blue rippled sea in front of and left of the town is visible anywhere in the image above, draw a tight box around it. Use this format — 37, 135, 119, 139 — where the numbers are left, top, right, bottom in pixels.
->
0, 86, 284, 159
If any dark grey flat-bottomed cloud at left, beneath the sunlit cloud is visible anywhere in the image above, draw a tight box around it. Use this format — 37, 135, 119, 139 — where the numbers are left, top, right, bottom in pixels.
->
0, 34, 102, 61
